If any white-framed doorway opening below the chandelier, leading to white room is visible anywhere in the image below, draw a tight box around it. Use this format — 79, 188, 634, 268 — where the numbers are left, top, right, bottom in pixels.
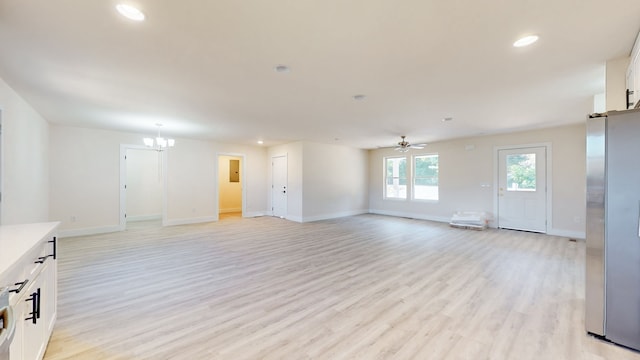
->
120, 145, 166, 230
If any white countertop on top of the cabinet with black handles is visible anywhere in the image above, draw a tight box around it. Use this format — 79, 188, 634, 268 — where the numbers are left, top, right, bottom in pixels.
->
0, 222, 60, 275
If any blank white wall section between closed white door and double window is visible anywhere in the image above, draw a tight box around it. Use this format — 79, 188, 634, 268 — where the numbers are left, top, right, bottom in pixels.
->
302, 142, 369, 221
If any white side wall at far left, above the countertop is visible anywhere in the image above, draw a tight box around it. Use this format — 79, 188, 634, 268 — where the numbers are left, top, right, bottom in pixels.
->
0, 79, 49, 225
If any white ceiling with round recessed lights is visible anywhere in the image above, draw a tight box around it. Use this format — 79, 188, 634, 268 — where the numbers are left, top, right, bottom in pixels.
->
0, 0, 640, 148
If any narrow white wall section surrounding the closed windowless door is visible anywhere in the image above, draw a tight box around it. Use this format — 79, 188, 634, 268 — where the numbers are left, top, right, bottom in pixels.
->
267, 142, 303, 222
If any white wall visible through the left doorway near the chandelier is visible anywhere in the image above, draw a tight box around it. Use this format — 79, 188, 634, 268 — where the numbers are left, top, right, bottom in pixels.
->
126, 149, 163, 221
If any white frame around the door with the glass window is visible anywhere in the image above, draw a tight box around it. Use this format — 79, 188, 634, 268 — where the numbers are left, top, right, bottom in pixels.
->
493, 142, 553, 234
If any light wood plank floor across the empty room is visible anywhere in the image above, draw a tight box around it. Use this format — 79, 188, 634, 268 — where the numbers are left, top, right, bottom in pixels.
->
45, 215, 640, 360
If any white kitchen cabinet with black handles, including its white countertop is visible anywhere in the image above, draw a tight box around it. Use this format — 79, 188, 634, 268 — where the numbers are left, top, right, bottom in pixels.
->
0, 223, 58, 360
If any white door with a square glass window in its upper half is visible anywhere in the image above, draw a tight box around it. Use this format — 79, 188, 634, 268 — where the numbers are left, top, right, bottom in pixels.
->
498, 146, 547, 233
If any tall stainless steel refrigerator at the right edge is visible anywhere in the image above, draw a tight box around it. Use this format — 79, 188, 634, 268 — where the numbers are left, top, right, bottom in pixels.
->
585, 109, 640, 350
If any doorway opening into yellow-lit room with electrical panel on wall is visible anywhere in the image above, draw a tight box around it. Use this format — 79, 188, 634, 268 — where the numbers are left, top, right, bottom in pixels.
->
218, 154, 244, 220
